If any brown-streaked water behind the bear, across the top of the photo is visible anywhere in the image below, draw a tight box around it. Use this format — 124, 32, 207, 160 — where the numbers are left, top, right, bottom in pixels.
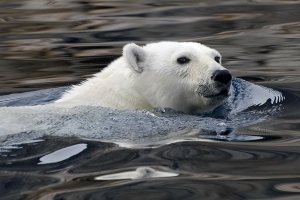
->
0, 0, 300, 93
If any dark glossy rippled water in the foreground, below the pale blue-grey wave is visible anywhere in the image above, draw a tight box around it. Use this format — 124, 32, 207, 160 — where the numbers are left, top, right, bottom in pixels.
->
0, 137, 300, 199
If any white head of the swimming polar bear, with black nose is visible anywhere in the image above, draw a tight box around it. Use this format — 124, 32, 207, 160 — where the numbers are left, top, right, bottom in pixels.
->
123, 42, 232, 113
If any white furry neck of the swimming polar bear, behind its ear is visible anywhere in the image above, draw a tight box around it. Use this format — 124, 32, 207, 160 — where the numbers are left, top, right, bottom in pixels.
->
58, 58, 152, 110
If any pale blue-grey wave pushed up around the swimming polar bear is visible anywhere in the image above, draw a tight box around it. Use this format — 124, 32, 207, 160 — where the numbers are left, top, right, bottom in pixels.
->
0, 78, 285, 147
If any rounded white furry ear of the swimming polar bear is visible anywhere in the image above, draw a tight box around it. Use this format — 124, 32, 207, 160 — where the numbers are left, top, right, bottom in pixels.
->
123, 43, 146, 72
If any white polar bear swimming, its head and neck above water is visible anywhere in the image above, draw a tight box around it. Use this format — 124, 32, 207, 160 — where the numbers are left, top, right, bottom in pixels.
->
55, 42, 232, 113
